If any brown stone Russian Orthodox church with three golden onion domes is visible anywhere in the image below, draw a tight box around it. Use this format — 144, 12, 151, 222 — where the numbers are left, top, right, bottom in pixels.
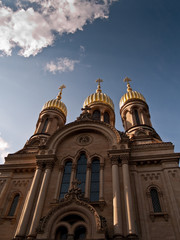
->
0, 78, 180, 240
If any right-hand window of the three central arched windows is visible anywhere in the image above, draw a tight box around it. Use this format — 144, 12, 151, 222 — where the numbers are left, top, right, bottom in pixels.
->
90, 159, 100, 201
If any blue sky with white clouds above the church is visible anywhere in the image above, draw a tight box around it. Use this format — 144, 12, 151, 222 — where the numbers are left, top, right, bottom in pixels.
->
0, 0, 180, 162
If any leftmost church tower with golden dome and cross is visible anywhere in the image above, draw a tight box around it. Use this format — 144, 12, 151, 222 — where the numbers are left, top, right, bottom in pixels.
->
35, 85, 67, 135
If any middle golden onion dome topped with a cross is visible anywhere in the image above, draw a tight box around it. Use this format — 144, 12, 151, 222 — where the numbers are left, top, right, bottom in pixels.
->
83, 78, 114, 110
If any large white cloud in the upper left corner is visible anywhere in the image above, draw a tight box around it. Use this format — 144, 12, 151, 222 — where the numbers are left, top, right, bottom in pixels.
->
0, 0, 116, 57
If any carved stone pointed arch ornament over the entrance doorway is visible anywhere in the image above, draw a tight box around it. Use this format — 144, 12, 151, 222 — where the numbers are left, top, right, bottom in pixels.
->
36, 182, 106, 233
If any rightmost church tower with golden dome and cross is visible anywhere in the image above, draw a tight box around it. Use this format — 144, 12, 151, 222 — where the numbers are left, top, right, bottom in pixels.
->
119, 77, 161, 141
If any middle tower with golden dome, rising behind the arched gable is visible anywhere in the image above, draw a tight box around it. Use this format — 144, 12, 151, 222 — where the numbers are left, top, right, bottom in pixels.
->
83, 78, 115, 126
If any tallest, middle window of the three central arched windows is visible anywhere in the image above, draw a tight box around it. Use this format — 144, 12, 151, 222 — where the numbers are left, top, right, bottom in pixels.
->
76, 153, 87, 193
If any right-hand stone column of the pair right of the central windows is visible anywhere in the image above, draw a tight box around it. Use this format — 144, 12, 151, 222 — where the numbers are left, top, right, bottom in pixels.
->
121, 157, 136, 237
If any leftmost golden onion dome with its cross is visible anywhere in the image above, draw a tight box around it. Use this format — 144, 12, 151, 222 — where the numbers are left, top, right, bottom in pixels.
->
42, 85, 67, 116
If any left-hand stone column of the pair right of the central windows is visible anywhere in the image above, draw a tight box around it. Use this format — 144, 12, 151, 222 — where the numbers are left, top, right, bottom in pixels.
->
111, 157, 122, 239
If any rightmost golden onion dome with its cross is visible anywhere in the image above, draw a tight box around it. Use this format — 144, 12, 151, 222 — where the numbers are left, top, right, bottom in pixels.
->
119, 77, 146, 108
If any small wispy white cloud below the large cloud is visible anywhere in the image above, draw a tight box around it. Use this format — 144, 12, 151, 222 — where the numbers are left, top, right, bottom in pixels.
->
46, 58, 79, 74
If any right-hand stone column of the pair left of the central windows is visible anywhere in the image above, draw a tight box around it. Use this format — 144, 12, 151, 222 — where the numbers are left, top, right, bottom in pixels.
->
28, 161, 54, 239
